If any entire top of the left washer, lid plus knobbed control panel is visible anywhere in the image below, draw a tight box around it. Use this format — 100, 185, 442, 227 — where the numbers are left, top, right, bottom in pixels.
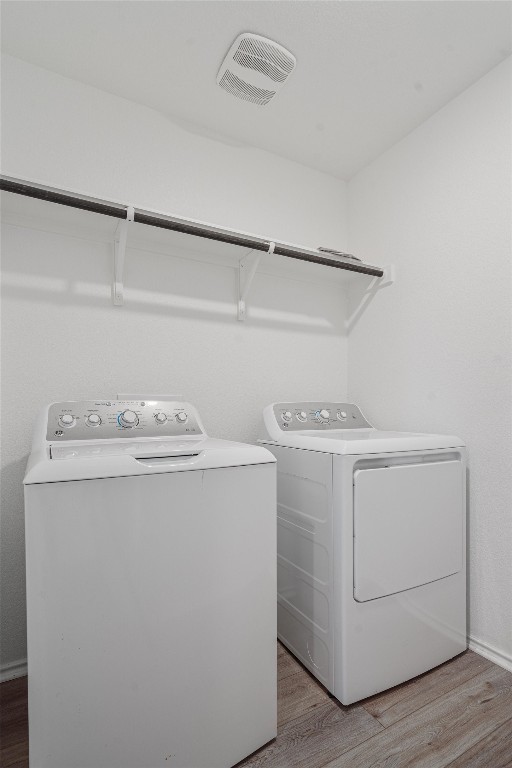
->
24, 395, 275, 485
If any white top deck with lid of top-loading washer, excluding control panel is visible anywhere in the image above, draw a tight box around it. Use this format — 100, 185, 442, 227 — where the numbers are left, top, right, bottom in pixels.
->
23, 437, 275, 485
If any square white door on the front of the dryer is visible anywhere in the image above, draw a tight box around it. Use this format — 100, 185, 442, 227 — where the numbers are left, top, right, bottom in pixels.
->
354, 460, 465, 602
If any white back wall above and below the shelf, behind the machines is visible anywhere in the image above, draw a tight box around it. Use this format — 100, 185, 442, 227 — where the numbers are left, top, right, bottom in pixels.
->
2, 57, 346, 666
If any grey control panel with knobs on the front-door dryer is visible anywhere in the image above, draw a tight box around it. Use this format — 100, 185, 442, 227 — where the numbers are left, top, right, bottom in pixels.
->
272, 402, 372, 432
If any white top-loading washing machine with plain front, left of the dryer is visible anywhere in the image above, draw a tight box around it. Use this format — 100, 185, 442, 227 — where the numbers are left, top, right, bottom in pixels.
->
25, 400, 276, 768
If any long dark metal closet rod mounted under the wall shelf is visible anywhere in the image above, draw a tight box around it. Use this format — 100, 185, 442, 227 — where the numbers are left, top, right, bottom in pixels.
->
0, 176, 384, 277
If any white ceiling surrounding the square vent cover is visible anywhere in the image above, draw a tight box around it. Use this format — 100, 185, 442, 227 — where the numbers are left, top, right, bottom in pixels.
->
1, 0, 512, 179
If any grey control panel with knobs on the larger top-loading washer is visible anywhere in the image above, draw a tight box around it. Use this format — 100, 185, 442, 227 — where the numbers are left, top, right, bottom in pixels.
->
46, 400, 204, 442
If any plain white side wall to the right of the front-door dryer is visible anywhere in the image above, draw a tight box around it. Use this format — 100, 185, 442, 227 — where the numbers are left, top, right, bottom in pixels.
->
348, 60, 512, 664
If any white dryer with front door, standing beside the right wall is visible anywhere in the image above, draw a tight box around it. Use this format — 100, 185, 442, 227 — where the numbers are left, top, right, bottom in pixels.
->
261, 402, 467, 704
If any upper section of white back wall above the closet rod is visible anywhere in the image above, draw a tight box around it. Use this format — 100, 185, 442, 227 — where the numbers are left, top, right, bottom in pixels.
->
2, 55, 345, 250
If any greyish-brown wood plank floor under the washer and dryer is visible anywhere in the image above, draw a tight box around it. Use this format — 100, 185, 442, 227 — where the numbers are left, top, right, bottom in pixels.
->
0, 645, 512, 768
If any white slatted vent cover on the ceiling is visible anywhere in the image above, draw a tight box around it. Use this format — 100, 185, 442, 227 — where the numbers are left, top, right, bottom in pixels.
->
217, 32, 296, 106
